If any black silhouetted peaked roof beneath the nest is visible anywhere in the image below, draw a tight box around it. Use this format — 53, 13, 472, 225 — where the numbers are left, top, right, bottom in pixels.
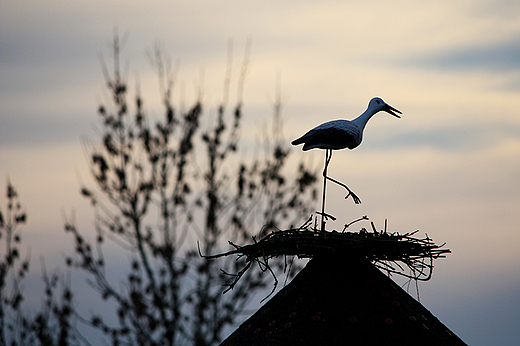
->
221, 252, 465, 346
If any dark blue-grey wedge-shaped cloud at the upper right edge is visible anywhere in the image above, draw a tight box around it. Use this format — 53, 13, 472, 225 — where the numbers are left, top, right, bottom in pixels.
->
402, 38, 520, 72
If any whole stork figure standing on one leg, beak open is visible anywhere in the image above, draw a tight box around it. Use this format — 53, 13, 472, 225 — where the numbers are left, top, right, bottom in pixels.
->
291, 97, 402, 231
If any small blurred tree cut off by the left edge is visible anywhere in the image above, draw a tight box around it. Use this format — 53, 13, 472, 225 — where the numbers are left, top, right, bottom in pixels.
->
0, 181, 88, 346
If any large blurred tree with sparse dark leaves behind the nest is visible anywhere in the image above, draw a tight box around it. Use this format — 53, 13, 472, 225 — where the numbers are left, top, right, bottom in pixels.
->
65, 35, 316, 345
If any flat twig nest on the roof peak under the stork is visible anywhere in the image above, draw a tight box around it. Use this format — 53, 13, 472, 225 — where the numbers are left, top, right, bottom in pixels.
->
201, 217, 451, 298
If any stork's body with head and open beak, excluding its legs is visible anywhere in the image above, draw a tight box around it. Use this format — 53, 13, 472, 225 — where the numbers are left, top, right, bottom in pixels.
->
291, 97, 401, 151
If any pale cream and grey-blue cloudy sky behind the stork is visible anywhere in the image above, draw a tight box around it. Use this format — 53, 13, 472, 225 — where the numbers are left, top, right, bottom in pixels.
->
0, 0, 520, 345
